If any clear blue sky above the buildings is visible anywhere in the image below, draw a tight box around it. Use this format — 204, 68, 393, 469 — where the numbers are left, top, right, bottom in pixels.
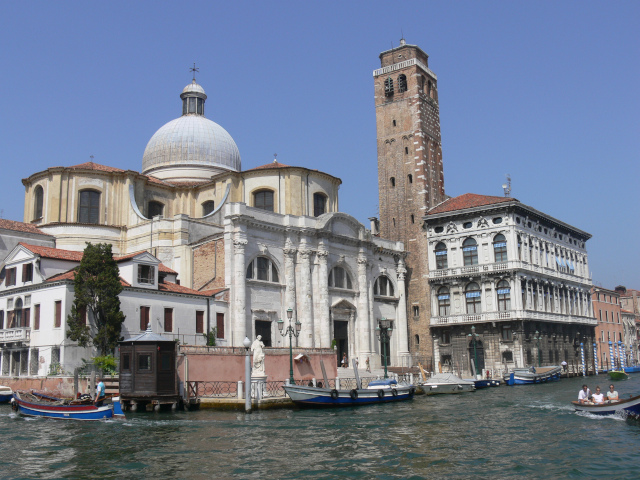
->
0, 1, 640, 288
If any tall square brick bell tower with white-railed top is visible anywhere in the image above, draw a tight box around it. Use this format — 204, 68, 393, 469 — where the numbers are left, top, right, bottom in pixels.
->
373, 39, 445, 368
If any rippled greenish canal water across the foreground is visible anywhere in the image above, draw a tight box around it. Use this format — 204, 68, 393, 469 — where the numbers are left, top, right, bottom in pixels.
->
0, 374, 640, 479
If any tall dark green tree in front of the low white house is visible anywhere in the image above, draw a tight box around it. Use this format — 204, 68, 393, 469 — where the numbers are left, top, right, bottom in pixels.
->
67, 243, 125, 356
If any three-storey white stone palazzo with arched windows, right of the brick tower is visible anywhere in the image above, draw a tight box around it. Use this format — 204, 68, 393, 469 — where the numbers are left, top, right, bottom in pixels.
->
424, 194, 597, 372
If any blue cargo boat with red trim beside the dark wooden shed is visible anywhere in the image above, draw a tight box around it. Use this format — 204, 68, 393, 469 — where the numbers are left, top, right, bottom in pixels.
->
12, 391, 124, 420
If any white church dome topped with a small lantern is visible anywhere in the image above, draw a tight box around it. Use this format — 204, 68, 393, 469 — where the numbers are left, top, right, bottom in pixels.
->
142, 80, 241, 180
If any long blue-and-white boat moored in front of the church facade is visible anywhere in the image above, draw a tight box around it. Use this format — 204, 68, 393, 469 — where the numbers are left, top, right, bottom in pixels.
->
284, 379, 416, 407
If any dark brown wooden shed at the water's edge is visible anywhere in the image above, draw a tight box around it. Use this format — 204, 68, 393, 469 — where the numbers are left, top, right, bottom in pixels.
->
120, 327, 180, 411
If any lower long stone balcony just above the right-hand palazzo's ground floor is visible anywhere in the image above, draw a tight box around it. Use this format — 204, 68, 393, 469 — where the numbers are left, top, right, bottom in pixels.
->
430, 310, 598, 327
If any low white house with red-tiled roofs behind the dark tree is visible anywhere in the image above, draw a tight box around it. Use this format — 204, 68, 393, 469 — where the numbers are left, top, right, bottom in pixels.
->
0, 243, 227, 376
